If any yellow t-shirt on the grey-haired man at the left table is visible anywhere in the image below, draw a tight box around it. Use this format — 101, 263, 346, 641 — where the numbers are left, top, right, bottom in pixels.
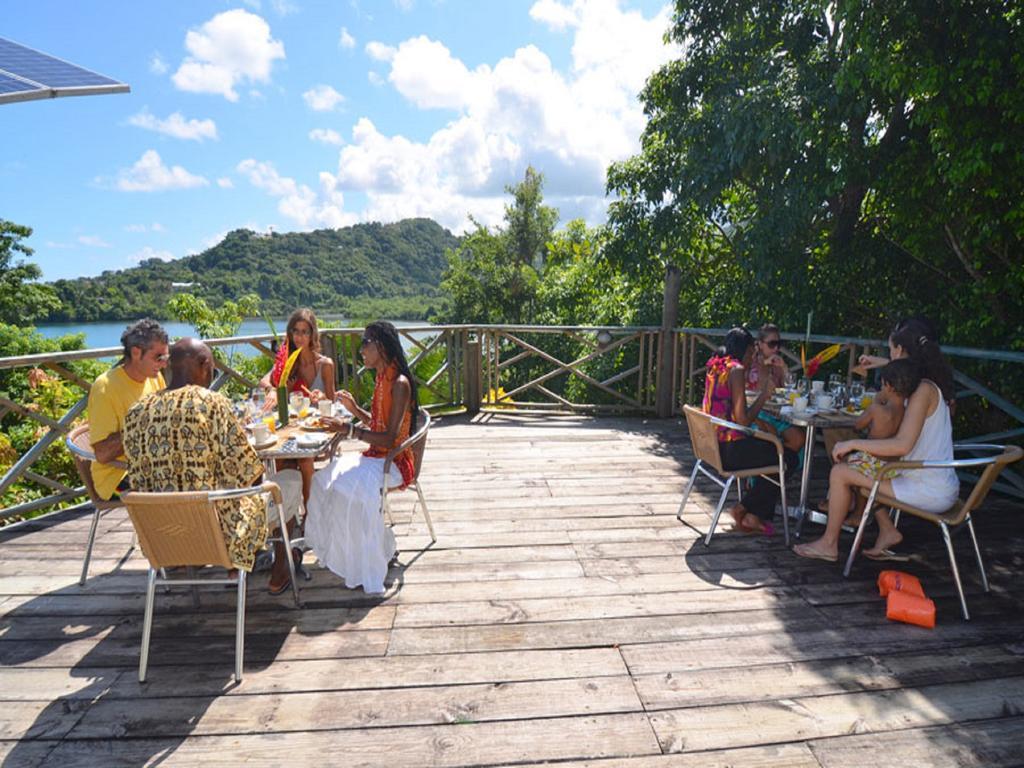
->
89, 366, 164, 499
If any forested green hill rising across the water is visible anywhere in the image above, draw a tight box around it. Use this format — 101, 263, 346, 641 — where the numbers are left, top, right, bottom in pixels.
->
47, 219, 459, 322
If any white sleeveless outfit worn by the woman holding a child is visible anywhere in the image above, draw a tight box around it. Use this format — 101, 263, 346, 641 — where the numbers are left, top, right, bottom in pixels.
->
892, 379, 959, 513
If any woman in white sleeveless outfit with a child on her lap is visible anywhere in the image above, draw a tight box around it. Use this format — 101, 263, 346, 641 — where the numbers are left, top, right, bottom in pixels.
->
793, 326, 959, 562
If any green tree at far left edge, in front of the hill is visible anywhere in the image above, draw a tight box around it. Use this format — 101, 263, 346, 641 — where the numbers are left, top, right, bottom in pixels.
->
0, 219, 60, 326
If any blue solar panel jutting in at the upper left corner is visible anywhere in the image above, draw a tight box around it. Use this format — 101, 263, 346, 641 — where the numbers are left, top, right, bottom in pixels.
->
0, 38, 129, 103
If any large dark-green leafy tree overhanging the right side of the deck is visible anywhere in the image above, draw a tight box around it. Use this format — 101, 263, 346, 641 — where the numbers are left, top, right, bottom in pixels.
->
608, 0, 1024, 347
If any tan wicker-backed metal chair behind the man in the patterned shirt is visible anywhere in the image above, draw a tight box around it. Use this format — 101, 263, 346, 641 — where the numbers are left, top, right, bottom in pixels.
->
123, 481, 299, 682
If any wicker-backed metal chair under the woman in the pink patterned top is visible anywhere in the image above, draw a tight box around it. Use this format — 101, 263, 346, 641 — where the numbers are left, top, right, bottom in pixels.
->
676, 406, 790, 547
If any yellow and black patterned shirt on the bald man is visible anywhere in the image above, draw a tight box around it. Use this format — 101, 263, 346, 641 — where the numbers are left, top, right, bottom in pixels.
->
124, 385, 267, 570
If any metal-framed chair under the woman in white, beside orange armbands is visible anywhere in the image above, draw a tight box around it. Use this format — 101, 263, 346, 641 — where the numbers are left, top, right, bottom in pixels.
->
843, 443, 1024, 621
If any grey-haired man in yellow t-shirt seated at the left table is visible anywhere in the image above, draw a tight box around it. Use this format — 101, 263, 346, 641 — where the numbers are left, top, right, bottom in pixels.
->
89, 319, 168, 499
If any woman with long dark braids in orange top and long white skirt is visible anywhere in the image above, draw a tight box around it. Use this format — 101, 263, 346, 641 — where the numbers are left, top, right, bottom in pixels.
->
305, 321, 419, 594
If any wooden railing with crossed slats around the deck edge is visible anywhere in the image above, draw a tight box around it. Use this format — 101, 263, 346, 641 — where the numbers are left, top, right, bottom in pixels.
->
0, 325, 1024, 520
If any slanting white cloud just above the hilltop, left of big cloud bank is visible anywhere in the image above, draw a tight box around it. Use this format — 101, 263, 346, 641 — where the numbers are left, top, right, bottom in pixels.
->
238, 159, 358, 228
